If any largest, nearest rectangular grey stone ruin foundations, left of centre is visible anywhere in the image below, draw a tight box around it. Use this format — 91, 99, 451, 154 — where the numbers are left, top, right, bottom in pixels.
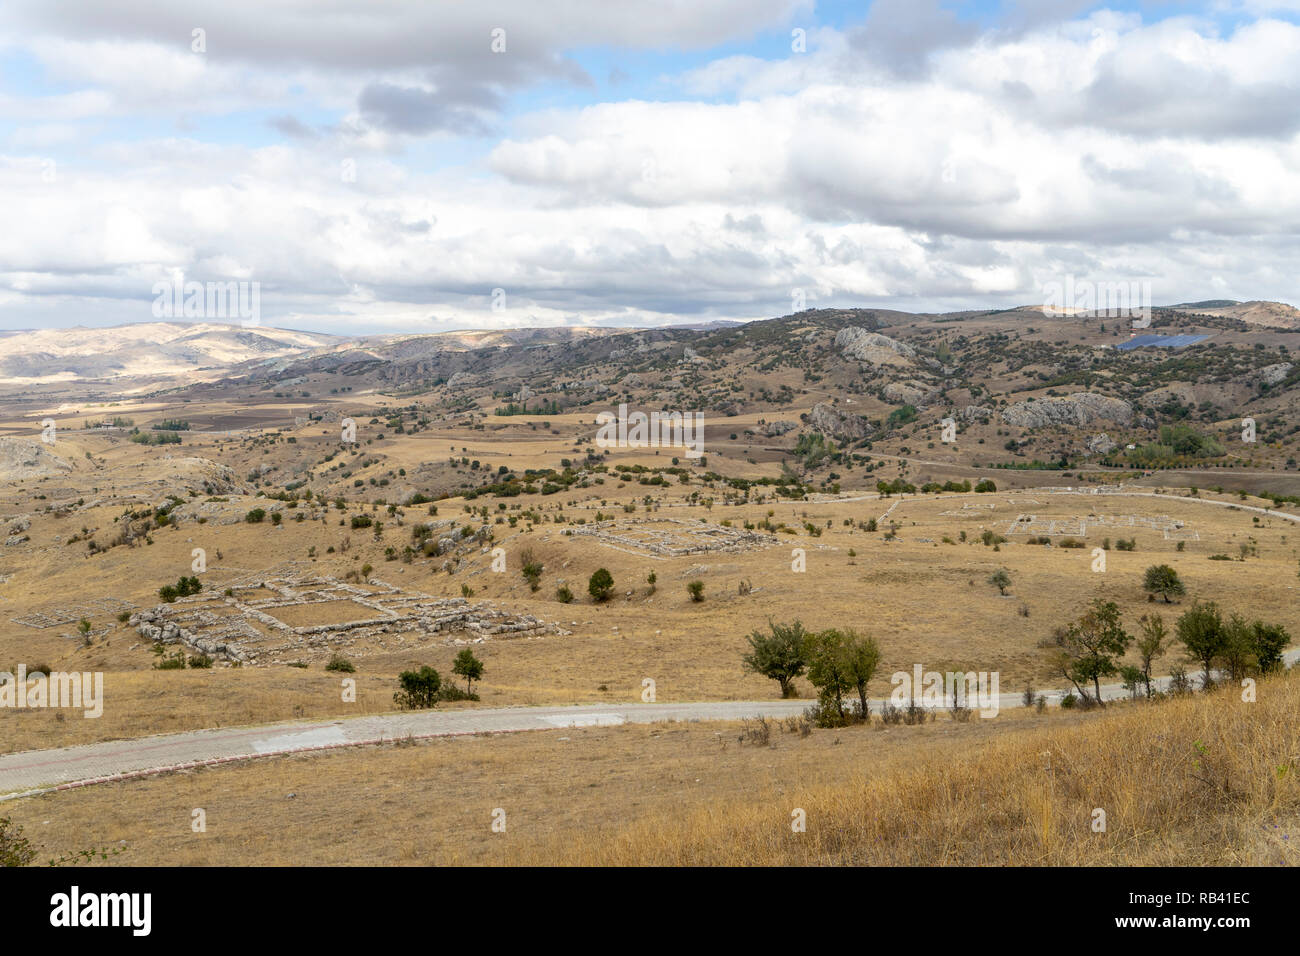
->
130, 575, 569, 665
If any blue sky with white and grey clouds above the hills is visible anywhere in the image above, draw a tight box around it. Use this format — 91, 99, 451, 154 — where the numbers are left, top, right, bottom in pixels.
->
0, 0, 1300, 336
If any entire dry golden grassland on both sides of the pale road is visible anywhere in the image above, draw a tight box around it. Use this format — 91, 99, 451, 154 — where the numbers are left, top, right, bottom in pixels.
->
0, 379, 1300, 865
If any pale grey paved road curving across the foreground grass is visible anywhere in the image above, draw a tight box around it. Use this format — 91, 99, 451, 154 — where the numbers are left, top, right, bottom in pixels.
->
0, 649, 1300, 801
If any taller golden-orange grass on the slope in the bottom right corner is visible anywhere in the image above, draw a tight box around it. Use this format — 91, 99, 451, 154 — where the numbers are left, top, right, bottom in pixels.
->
514, 675, 1300, 866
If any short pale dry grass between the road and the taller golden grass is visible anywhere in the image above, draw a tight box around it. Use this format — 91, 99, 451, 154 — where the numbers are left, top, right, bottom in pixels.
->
3, 711, 1091, 865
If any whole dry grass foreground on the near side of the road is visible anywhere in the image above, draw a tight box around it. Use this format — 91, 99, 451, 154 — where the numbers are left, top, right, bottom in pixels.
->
5, 676, 1300, 866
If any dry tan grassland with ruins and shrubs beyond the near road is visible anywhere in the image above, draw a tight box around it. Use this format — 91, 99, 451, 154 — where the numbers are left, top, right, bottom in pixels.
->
0, 398, 1300, 750
